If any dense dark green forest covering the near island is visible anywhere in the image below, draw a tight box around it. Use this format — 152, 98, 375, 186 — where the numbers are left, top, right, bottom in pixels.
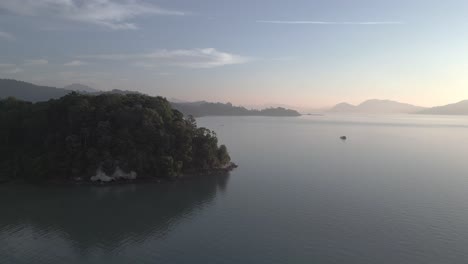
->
0, 93, 230, 181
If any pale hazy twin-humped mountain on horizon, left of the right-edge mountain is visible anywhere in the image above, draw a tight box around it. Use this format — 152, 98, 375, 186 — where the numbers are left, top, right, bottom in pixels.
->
328, 99, 424, 114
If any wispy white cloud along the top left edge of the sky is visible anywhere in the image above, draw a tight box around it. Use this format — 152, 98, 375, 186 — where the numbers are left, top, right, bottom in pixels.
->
0, 0, 185, 30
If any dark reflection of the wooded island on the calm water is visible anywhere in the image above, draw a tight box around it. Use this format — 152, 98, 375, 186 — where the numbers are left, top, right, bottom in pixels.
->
0, 174, 229, 252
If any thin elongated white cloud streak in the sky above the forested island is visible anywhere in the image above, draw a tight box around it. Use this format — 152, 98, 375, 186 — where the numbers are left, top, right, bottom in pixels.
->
80, 48, 252, 68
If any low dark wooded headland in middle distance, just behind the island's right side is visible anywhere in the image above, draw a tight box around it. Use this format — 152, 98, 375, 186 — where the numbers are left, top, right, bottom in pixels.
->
172, 102, 301, 117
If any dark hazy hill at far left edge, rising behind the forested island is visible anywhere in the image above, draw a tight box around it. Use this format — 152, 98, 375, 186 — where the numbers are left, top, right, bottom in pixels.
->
0, 79, 71, 102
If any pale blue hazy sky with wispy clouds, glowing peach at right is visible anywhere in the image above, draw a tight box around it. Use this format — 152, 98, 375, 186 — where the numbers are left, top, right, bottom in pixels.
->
0, 0, 468, 107
